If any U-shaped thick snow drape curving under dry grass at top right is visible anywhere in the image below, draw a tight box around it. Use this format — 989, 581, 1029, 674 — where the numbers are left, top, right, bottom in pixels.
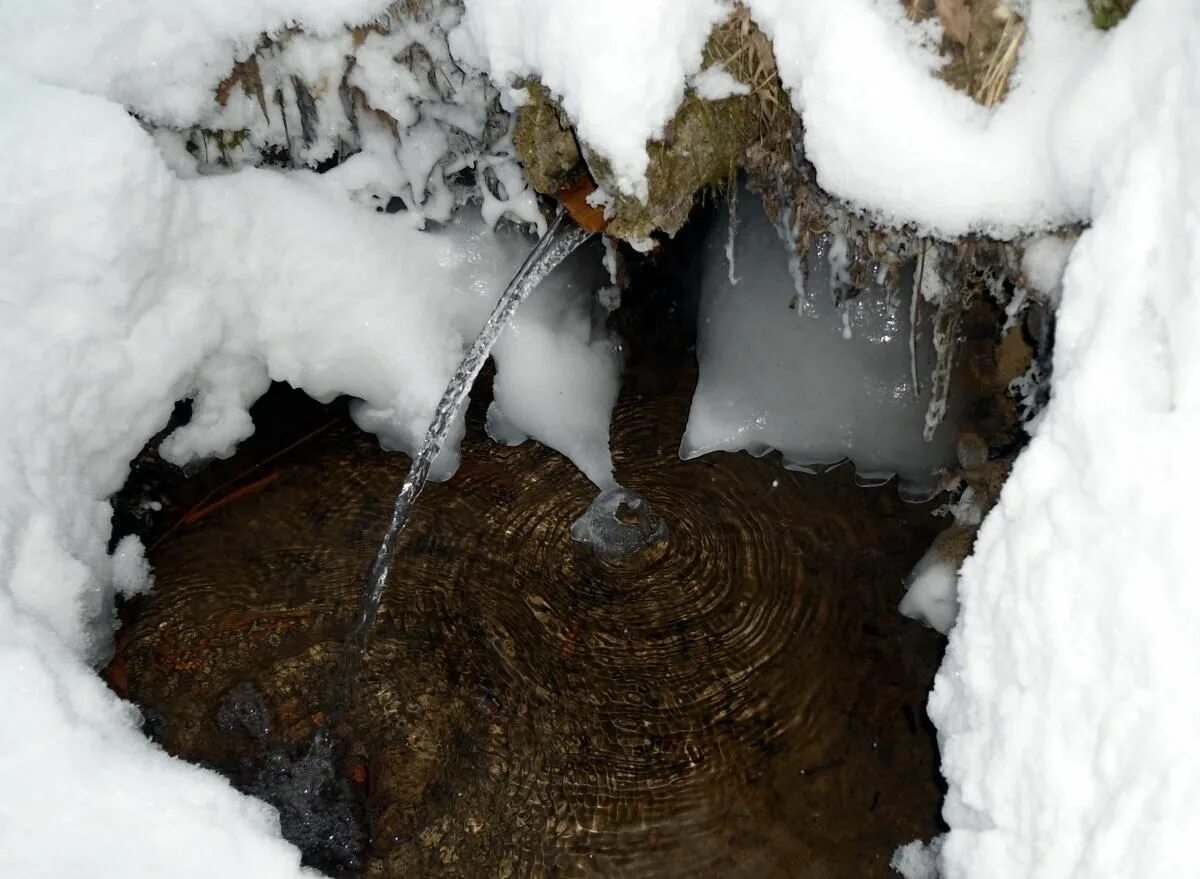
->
750, 0, 1123, 237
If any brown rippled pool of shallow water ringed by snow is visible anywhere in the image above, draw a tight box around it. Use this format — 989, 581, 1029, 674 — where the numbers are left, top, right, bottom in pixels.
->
114, 367, 943, 879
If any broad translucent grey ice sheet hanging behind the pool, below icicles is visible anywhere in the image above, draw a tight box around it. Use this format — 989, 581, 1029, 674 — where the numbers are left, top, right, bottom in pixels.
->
679, 191, 954, 497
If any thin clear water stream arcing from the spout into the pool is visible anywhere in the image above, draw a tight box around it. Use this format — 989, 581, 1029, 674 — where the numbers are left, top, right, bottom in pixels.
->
340, 210, 593, 667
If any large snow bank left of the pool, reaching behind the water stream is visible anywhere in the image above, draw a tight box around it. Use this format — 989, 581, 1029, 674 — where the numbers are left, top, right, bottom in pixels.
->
0, 58, 617, 877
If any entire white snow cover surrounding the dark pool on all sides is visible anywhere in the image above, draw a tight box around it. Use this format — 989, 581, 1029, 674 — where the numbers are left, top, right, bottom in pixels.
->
0, 0, 1200, 879
